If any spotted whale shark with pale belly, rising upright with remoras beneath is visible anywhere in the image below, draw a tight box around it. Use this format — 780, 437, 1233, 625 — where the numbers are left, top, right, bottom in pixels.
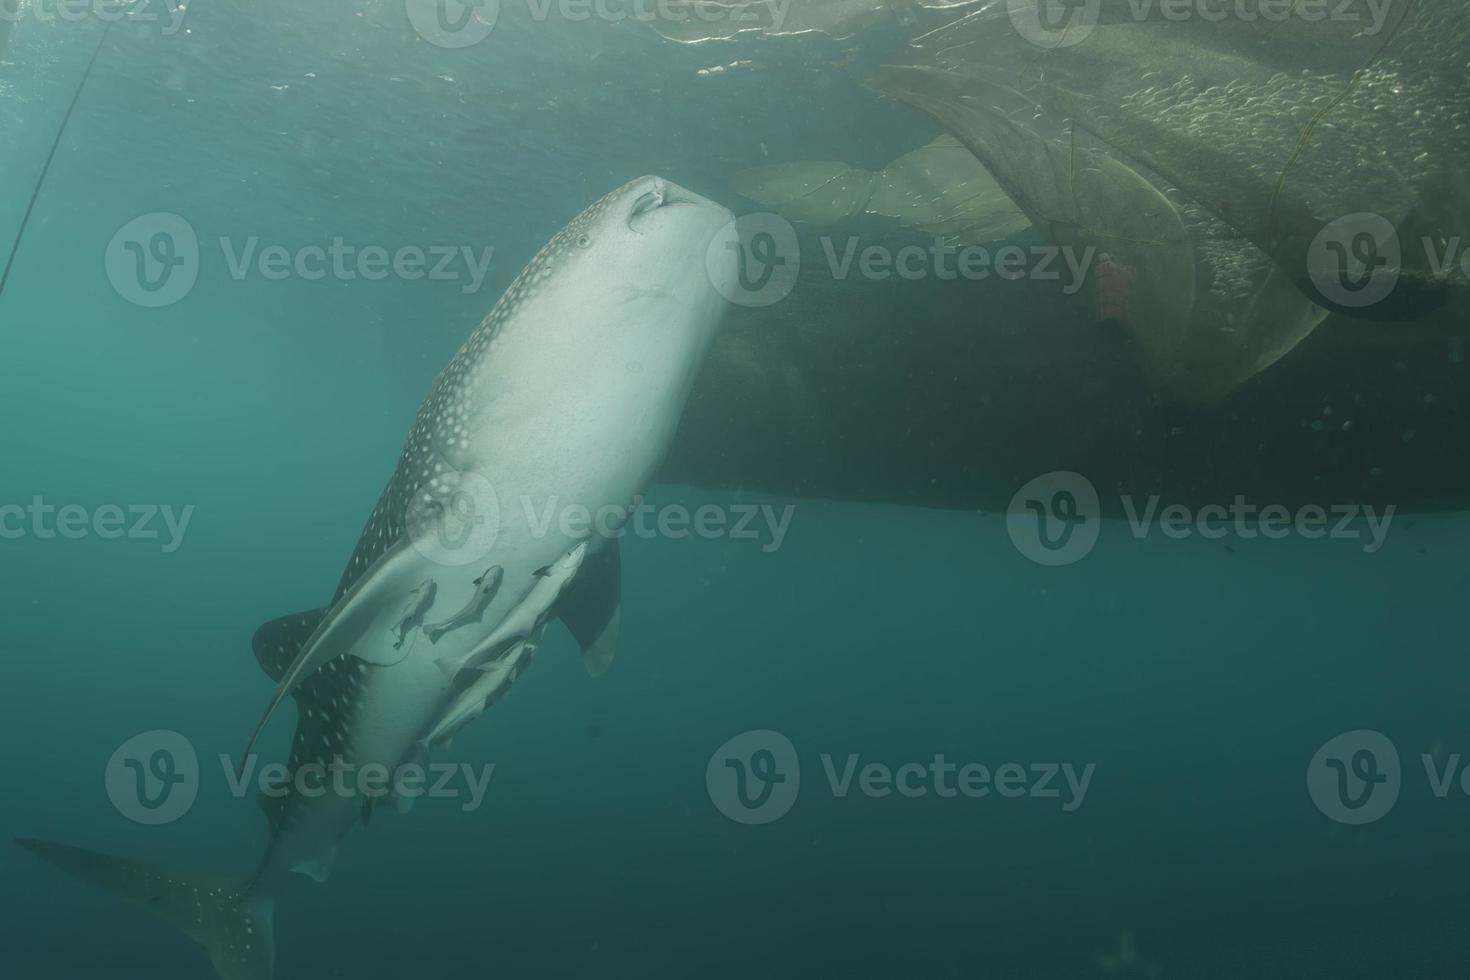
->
19, 176, 736, 980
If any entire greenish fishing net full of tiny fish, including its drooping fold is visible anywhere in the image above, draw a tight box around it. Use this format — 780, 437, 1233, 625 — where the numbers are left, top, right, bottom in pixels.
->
875, 0, 1470, 400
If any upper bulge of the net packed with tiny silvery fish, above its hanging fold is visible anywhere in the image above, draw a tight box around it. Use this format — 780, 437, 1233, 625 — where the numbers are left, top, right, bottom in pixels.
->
879, 0, 1470, 312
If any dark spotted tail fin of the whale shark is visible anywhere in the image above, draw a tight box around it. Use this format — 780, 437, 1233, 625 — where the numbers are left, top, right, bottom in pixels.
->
16, 837, 275, 980
